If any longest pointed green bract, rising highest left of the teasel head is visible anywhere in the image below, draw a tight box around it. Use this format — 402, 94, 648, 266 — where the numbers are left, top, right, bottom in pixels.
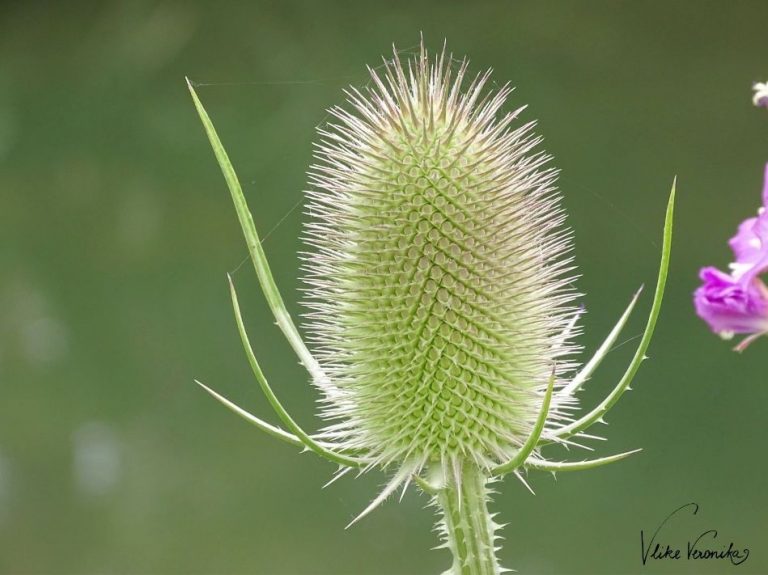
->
187, 78, 326, 388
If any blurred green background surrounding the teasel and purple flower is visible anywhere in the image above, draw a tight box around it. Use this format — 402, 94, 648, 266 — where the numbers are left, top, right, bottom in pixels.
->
0, 0, 768, 575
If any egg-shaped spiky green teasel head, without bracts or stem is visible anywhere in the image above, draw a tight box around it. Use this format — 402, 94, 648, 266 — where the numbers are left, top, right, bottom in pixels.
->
304, 47, 577, 476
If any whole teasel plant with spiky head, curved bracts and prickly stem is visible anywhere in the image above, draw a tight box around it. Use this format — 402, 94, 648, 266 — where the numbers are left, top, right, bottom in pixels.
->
188, 39, 675, 575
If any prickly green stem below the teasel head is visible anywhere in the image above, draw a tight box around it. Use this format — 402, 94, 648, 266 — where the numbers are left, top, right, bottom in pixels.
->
435, 464, 505, 575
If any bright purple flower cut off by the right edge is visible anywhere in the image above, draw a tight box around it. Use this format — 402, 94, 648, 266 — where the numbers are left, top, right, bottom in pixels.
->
693, 164, 768, 351
